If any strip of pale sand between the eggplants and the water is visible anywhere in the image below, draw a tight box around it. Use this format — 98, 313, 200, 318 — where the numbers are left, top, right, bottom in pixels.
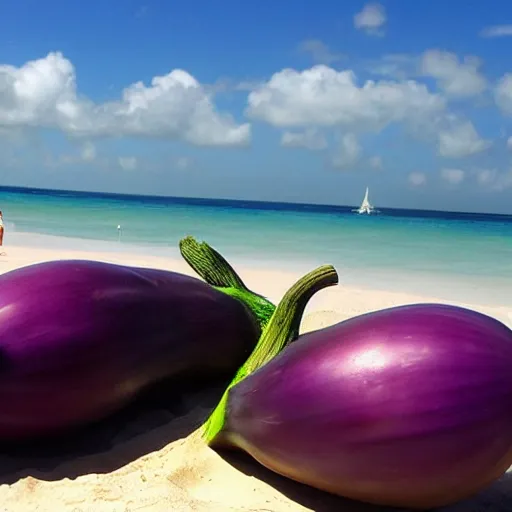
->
0, 237, 512, 330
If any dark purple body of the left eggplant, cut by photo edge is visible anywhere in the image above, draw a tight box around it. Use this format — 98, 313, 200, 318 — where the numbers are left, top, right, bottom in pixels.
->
0, 260, 260, 441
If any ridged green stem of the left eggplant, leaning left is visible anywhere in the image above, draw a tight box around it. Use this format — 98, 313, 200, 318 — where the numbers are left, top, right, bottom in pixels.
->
179, 236, 276, 331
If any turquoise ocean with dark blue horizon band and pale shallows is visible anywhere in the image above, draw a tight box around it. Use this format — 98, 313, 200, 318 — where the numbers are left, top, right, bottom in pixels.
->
0, 187, 512, 306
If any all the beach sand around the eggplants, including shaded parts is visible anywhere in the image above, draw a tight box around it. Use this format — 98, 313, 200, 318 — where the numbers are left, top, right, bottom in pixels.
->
0, 245, 512, 512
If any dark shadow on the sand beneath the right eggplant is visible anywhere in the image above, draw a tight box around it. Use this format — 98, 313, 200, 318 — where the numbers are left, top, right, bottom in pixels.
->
219, 451, 512, 512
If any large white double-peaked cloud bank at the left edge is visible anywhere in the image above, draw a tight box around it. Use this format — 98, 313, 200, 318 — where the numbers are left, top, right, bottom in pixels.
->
0, 52, 251, 146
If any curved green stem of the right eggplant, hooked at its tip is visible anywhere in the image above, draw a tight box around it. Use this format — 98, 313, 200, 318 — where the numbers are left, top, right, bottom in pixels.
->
203, 265, 338, 444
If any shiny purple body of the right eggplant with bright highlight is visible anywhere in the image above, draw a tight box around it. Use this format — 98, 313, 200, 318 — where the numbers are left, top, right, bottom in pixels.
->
205, 296, 512, 510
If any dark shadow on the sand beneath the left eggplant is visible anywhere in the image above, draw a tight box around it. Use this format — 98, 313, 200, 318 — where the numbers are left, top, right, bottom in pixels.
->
0, 382, 226, 485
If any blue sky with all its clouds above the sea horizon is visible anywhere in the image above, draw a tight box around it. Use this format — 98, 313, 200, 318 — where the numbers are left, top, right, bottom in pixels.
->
0, 0, 512, 214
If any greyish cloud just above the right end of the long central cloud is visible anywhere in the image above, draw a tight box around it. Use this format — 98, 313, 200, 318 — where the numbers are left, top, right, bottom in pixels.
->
420, 50, 487, 98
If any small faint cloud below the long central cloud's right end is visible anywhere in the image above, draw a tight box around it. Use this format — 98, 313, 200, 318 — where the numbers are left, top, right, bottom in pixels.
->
439, 121, 492, 158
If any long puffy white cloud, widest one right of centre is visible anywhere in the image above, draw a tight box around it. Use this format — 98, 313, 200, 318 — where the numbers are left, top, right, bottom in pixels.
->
246, 65, 445, 131
